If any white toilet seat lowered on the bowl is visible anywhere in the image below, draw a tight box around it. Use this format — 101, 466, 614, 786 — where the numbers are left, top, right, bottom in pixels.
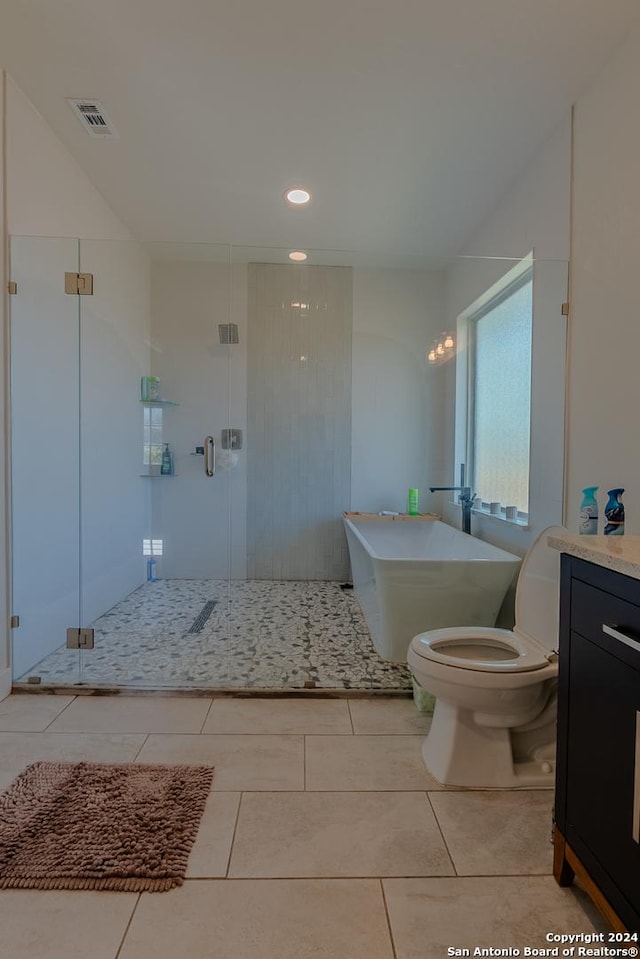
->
411, 626, 549, 673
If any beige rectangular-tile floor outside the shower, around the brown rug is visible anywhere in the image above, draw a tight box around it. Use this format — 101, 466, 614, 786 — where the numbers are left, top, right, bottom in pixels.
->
0, 695, 606, 959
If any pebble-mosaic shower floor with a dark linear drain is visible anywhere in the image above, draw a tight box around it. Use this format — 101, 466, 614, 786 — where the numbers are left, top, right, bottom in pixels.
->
19, 579, 411, 690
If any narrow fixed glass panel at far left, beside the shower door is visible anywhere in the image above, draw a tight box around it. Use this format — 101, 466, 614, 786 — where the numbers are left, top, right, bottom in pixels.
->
10, 236, 80, 685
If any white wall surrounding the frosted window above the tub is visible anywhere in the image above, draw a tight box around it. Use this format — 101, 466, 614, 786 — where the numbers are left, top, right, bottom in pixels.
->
440, 117, 571, 555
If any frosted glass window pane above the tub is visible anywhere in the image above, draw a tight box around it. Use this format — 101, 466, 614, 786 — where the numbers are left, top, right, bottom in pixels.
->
471, 272, 532, 514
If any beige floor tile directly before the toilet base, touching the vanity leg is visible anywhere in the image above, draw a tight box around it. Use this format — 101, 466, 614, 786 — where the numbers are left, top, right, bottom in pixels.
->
430, 789, 553, 876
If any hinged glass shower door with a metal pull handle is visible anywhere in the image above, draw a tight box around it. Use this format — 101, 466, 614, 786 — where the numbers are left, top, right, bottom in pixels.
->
80, 241, 229, 688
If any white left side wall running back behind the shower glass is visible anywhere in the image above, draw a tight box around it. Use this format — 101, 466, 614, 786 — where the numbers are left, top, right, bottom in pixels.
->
4, 80, 149, 679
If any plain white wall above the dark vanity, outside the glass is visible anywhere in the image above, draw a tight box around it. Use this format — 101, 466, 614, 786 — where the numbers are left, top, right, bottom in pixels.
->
567, 22, 640, 533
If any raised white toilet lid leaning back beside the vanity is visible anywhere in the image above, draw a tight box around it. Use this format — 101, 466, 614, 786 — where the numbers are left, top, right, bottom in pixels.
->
513, 526, 568, 651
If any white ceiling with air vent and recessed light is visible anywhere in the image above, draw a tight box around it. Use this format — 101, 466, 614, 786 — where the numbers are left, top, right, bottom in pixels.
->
0, 0, 640, 257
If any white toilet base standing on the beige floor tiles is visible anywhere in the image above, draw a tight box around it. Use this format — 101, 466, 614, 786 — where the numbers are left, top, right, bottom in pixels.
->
422, 699, 555, 789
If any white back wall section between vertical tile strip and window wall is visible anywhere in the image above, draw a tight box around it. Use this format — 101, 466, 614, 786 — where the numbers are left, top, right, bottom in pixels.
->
351, 268, 447, 512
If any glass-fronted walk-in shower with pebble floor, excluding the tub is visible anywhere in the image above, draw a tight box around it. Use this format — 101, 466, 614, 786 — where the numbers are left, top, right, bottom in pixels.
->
10, 237, 566, 690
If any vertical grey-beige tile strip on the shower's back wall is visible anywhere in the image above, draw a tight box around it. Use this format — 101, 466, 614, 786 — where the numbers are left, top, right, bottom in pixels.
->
247, 263, 352, 580
